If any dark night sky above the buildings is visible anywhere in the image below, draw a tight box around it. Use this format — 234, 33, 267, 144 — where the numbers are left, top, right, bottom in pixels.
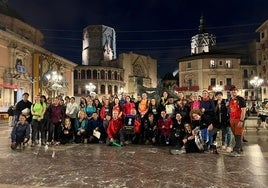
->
8, 0, 268, 77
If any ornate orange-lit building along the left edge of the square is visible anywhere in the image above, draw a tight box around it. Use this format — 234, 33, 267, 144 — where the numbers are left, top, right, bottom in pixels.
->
0, 13, 76, 108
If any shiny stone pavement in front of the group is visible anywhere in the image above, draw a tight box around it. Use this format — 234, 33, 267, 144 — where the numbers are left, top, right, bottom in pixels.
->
0, 124, 268, 188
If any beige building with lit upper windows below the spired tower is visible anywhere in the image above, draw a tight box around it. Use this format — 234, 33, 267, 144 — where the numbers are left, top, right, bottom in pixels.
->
177, 53, 242, 96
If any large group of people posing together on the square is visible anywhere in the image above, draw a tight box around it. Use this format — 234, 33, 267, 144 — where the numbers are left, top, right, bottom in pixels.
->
8, 86, 246, 154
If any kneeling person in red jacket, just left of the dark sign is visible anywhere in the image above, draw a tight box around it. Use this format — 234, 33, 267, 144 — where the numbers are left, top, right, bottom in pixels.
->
106, 110, 125, 146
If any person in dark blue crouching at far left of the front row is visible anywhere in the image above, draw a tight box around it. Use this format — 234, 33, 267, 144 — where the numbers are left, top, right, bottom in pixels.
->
10, 114, 30, 150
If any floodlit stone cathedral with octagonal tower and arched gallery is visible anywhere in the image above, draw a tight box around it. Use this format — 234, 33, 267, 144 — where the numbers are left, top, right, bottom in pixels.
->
74, 25, 157, 98
